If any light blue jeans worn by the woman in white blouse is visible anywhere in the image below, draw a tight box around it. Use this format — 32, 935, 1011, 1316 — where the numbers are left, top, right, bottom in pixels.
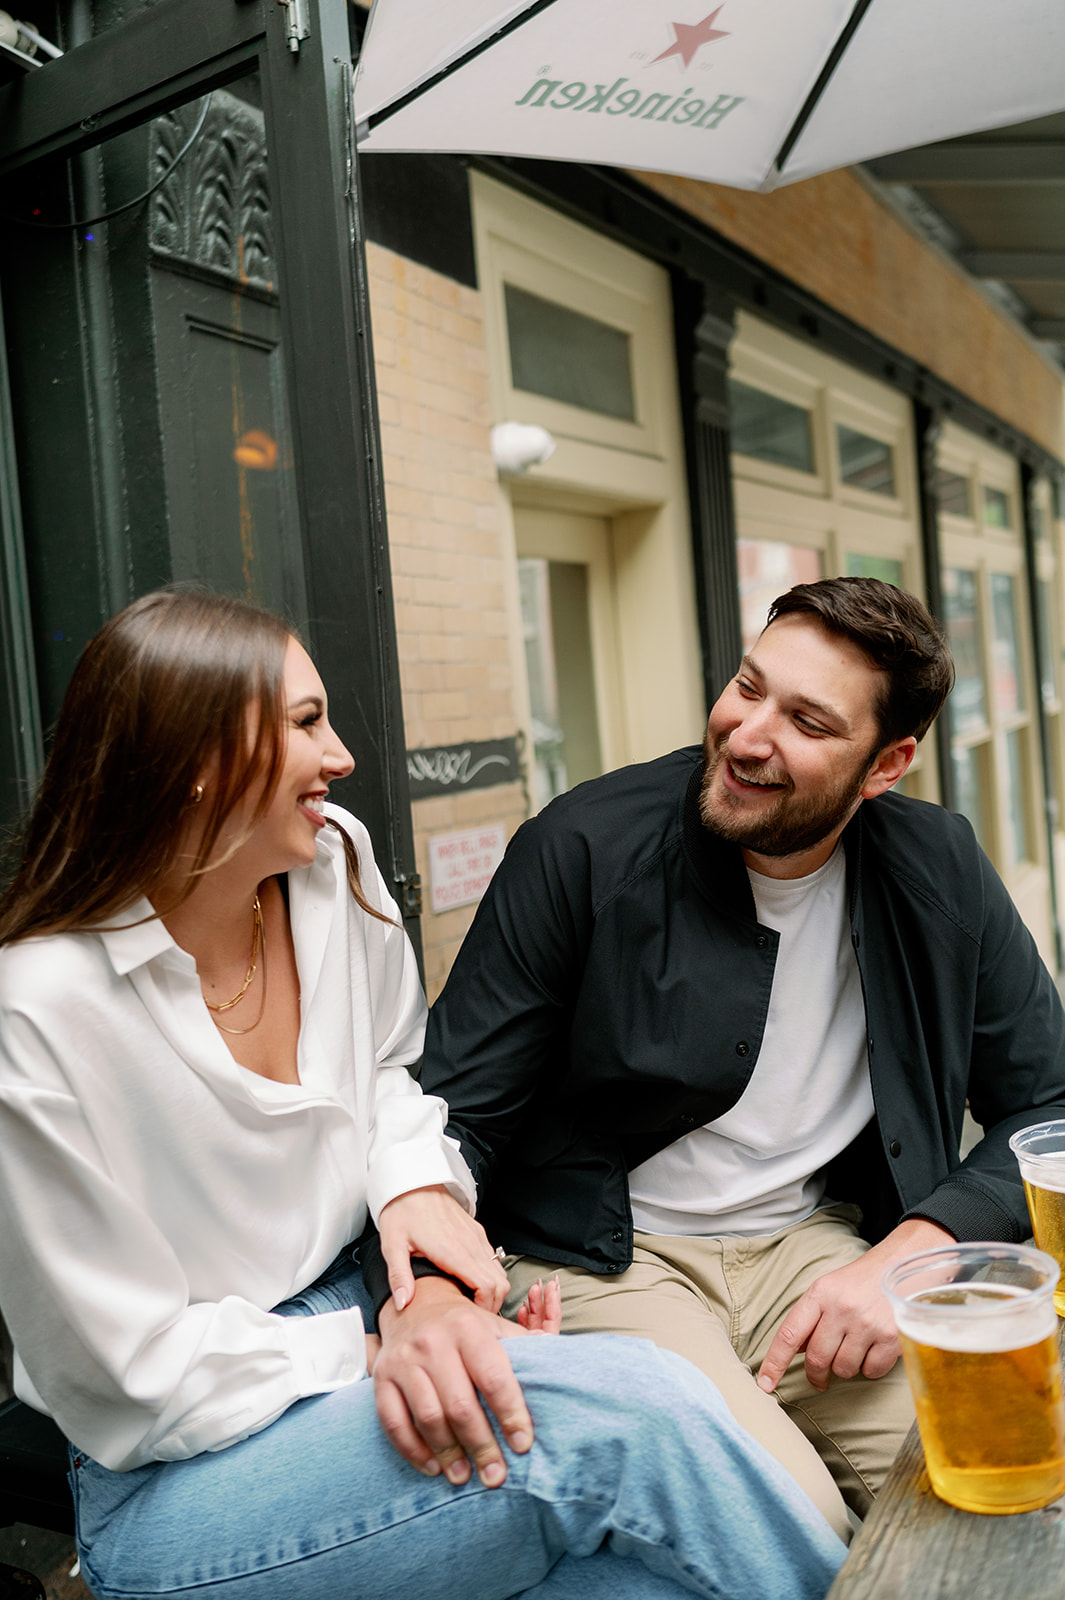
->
72, 1264, 843, 1600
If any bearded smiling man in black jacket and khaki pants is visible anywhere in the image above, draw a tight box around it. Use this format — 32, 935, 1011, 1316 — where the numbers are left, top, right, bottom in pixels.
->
422, 578, 1065, 1528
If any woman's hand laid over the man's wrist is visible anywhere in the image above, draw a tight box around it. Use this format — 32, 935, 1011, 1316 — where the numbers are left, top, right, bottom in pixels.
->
377, 1184, 510, 1312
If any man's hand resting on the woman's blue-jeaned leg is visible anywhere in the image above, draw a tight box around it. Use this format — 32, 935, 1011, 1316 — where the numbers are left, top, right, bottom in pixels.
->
373, 1278, 561, 1488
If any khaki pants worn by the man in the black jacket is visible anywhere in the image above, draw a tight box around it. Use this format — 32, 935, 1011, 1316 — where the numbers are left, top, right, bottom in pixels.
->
504, 1205, 913, 1539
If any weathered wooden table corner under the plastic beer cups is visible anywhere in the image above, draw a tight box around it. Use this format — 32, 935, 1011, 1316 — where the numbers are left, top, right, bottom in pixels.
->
827, 1322, 1065, 1600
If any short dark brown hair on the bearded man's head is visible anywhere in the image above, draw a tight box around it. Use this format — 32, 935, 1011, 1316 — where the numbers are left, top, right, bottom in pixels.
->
766, 578, 955, 746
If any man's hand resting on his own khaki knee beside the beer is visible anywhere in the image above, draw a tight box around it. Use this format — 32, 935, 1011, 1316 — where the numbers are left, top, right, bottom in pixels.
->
758, 1218, 955, 1392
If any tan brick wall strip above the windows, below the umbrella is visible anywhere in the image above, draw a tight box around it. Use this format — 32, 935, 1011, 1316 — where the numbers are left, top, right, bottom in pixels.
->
633, 171, 1065, 456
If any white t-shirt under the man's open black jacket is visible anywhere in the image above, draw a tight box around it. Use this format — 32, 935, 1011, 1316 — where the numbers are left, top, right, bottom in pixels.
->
628, 845, 873, 1238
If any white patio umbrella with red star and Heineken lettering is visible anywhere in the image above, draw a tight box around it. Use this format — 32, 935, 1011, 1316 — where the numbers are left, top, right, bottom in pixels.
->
355, 0, 1065, 189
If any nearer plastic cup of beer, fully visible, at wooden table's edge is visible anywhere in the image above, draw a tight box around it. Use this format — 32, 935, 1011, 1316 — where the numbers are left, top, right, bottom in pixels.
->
883, 1245, 1065, 1515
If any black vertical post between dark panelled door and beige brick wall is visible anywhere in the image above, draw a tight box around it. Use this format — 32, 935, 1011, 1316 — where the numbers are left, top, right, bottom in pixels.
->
262, 0, 421, 949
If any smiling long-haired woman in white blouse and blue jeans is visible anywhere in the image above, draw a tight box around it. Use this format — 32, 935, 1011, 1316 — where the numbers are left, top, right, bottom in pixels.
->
0, 590, 841, 1600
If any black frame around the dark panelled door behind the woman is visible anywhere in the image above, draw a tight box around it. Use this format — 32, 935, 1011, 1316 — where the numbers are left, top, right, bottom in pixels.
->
0, 0, 417, 933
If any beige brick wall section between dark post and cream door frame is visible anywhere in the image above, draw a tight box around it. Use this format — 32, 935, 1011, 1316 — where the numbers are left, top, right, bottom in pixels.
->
366, 245, 525, 1000
